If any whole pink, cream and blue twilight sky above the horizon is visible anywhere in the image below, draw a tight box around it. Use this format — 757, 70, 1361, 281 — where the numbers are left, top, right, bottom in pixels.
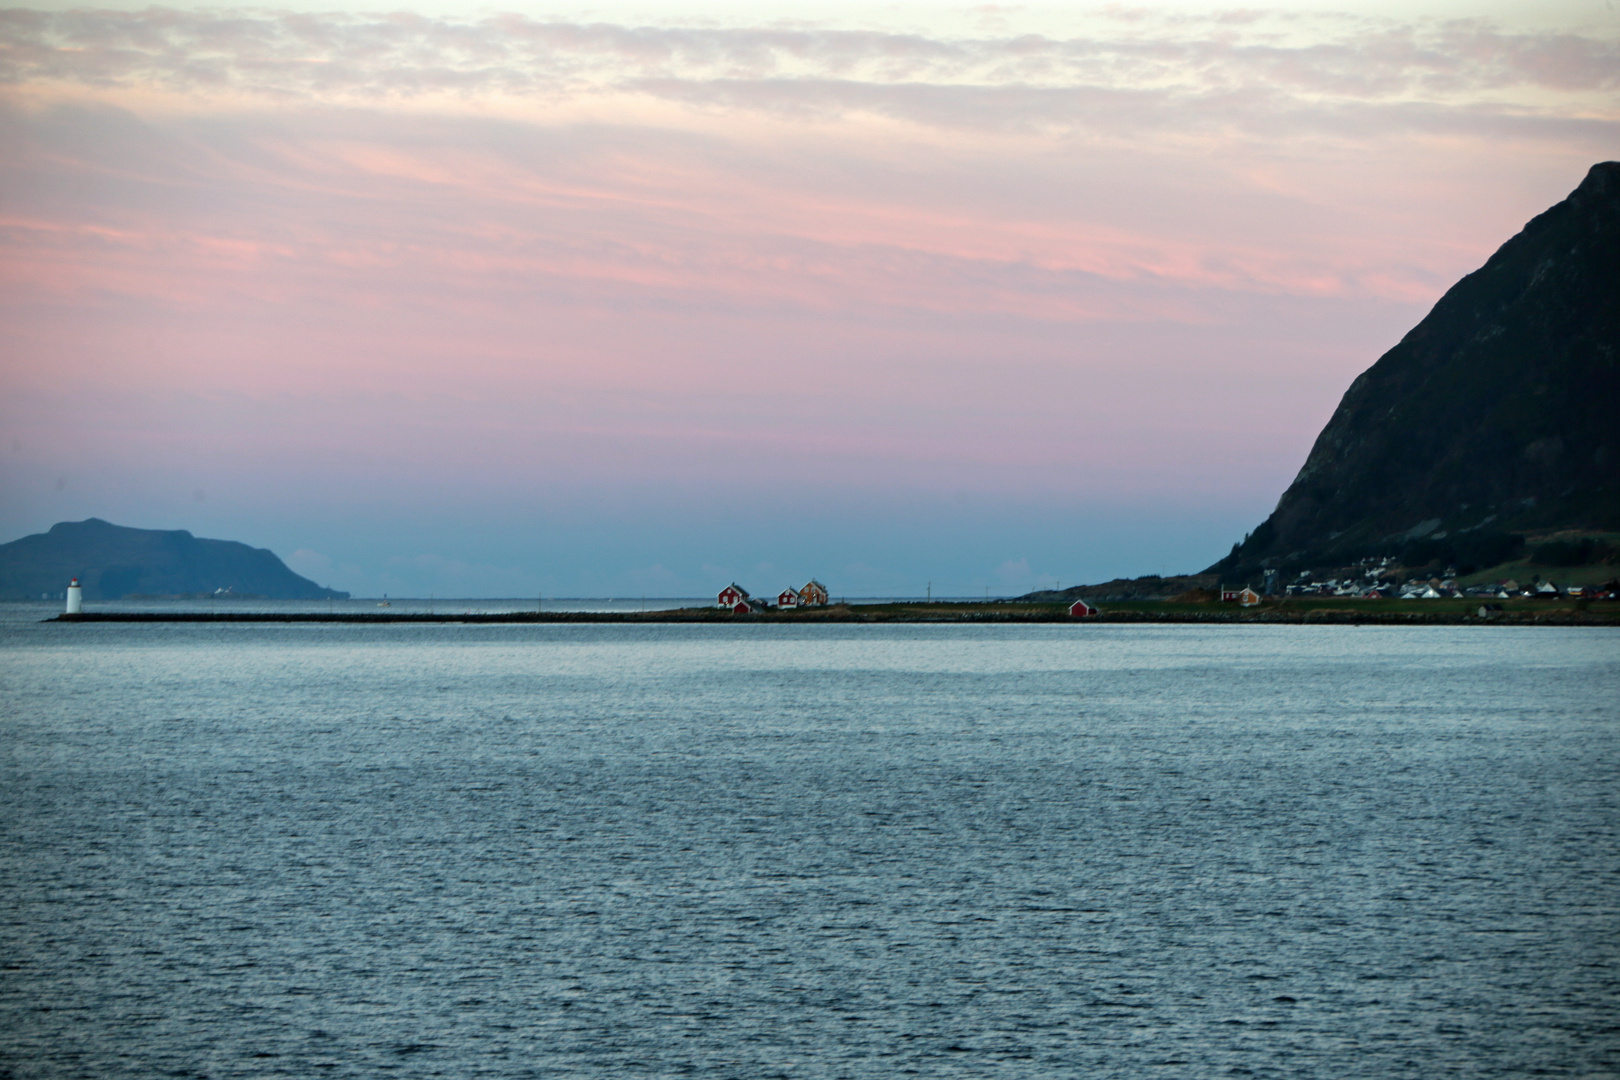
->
0, 0, 1620, 597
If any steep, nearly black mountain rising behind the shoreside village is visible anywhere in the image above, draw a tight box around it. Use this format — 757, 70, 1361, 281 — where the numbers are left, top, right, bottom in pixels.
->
1209, 162, 1620, 583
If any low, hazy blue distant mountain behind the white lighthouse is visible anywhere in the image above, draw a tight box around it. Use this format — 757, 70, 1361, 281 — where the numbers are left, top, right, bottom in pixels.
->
0, 518, 348, 601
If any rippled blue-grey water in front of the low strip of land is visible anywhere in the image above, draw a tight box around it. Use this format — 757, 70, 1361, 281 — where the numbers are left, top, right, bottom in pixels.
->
0, 617, 1620, 1078
